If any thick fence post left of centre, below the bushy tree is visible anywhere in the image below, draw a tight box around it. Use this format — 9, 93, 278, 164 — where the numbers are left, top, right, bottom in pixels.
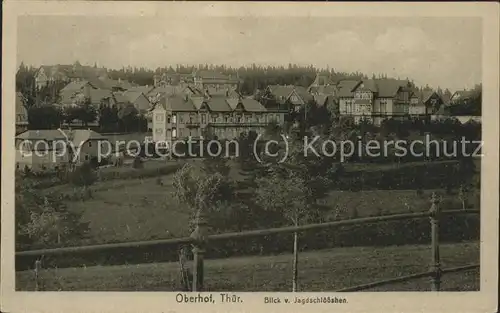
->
191, 209, 208, 291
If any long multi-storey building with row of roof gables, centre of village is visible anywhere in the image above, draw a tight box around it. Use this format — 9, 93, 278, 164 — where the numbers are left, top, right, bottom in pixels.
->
152, 89, 285, 142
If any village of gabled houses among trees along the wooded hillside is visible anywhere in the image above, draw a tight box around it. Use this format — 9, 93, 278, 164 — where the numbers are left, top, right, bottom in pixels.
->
15, 62, 481, 168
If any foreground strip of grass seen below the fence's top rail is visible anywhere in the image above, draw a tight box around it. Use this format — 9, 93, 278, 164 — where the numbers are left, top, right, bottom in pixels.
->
16, 243, 479, 291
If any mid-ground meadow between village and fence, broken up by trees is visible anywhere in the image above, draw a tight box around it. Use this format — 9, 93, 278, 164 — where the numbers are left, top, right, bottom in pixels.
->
37, 161, 475, 243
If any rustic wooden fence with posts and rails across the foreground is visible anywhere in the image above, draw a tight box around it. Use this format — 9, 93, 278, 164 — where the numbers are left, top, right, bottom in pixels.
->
16, 194, 479, 291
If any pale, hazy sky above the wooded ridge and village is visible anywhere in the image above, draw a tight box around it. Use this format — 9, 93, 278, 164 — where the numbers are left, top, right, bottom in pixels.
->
17, 15, 482, 90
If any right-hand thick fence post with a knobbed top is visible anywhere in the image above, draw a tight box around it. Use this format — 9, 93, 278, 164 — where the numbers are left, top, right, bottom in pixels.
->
429, 193, 442, 291
